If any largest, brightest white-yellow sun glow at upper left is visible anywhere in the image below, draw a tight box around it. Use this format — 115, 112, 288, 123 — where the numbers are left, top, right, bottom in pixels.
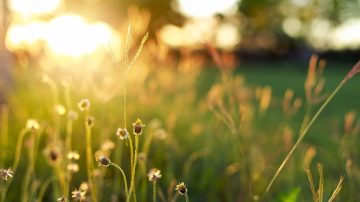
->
6, 15, 118, 57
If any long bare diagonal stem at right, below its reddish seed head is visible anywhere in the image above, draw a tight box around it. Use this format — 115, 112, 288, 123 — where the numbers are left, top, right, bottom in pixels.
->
264, 79, 346, 195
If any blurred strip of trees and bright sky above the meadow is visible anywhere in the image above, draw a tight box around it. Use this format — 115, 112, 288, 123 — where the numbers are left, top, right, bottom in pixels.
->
1, 0, 360, 60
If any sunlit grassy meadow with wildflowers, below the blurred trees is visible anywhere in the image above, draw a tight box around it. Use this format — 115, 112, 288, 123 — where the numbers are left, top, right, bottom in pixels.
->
0, 35, 360, 202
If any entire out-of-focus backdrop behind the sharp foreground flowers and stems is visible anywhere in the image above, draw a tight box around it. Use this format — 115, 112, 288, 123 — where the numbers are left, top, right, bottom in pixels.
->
0, 0, 360, 202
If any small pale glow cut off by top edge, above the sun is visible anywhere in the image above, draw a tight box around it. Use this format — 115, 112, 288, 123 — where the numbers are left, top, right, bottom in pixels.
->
9, 0, 61, 15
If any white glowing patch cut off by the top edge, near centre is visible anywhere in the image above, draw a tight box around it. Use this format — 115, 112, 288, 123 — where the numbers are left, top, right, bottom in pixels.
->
177, 0, 239, 17
